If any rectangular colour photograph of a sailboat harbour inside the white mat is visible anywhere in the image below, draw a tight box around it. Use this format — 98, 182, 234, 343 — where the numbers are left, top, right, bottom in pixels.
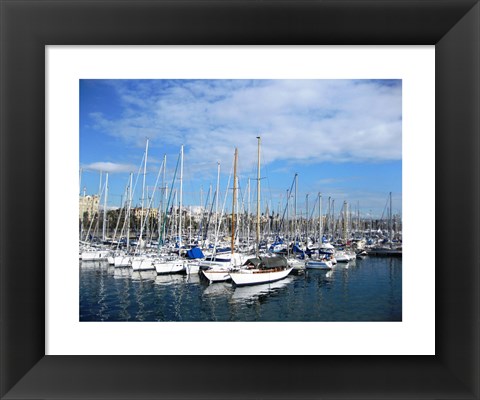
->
78, 79, 403, 322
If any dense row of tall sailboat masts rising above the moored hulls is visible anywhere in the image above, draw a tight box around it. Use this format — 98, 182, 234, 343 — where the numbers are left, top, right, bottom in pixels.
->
80, 137, 401, 250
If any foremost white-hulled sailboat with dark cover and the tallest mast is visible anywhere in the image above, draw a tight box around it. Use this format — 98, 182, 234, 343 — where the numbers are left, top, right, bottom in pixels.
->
229, 136, 293, 286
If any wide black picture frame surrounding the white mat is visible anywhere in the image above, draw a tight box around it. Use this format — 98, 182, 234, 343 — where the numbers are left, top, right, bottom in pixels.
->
0, 0, 480, 399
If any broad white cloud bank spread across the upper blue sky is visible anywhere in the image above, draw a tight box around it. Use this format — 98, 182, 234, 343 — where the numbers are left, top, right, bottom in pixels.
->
85, 80, 402, 174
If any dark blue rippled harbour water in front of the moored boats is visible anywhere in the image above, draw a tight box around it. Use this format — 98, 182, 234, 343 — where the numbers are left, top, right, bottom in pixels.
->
79, 257, 402, 322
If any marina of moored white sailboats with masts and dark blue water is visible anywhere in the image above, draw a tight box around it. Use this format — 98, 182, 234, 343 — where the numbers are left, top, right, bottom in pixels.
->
79, 137, 402, 321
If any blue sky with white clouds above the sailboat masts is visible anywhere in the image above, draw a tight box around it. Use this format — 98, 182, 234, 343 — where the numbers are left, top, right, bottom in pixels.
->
79, 79, 402, 218
